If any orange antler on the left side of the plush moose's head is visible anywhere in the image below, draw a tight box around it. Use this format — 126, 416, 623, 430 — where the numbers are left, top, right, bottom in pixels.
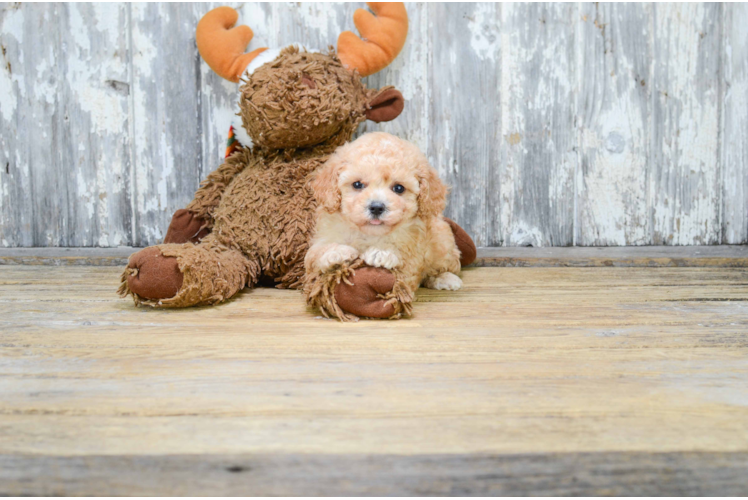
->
195, 7, 267, 82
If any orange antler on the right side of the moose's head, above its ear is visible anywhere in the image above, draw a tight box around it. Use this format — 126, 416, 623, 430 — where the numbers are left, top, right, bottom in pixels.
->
338, 2, 408, 76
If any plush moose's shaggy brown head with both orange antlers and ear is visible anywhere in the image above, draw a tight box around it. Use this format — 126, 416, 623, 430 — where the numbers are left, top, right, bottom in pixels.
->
197, 2, 408, 149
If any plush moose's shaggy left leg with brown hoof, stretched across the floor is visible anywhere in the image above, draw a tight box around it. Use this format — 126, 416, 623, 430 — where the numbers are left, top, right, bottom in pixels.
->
119, 235, 259, 307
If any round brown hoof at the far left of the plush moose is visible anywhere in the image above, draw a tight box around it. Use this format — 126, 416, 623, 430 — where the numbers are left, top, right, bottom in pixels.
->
127, 247, 184, 300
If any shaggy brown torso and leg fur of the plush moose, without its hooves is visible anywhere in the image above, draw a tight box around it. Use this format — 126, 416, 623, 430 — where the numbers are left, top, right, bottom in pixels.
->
142, 148, 322, 307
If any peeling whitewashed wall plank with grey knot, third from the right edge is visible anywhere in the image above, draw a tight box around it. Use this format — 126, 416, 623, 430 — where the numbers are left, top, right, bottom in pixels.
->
575, 3, 653, 246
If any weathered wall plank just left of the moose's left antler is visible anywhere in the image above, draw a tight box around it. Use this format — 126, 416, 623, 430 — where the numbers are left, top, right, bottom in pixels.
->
130, 3, 202, 246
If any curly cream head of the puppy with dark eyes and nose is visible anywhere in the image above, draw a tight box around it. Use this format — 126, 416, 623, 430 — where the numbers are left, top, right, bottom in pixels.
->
312, 132, 447, 235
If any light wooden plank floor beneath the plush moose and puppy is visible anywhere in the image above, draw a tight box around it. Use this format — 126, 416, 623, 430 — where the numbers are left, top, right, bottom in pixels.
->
0, 266, 748, 495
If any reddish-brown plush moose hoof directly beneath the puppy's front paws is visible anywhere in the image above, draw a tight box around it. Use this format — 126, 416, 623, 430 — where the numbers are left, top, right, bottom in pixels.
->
335, 267, 395, 318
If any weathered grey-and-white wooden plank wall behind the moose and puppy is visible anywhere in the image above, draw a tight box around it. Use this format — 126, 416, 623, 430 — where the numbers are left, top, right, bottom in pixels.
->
0, 3, 748, 247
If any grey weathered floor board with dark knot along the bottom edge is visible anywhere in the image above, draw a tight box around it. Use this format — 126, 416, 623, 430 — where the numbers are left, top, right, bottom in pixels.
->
0, 452, 748, 498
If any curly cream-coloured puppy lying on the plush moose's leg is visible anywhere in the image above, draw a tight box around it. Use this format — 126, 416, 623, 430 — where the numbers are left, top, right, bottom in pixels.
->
304, 132, 462, 298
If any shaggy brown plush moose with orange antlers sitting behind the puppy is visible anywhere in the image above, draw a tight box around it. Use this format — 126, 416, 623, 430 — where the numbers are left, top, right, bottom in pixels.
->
119, 2, 475, 317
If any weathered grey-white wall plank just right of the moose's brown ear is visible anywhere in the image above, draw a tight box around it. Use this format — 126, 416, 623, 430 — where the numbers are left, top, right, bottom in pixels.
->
429, 2, 501, 246
